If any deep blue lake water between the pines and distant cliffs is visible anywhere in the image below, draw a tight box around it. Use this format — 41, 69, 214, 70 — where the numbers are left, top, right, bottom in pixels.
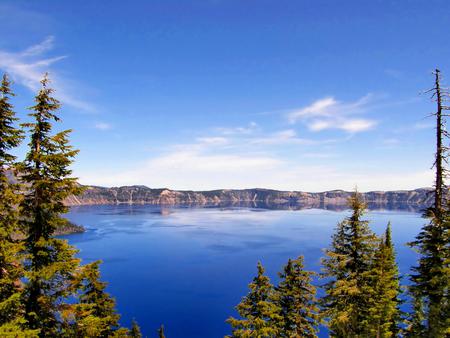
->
66, 205, 424, 338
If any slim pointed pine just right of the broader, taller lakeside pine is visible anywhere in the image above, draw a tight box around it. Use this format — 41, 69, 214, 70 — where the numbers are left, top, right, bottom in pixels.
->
367, 223, 401, 338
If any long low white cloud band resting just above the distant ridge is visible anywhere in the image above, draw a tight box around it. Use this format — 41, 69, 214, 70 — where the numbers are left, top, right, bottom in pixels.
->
77, 151, 433, 191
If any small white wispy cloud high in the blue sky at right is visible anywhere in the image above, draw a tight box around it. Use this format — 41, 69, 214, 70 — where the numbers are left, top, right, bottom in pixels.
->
287, 94, 377, 133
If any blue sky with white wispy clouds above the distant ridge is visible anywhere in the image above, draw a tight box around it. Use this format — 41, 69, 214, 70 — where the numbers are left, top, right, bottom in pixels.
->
0, 0, 450, 191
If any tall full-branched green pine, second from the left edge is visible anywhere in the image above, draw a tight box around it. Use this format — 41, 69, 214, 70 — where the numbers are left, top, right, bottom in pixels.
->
20, 76, 84, 337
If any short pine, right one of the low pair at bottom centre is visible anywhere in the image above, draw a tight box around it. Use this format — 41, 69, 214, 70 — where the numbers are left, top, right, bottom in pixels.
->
275, 256, 319, 338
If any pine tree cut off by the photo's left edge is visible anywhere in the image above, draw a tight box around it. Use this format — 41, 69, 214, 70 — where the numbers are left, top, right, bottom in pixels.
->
0, 74, 36, 336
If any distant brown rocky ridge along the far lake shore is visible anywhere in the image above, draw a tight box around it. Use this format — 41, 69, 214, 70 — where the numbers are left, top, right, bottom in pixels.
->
66, 185, 433, 208
